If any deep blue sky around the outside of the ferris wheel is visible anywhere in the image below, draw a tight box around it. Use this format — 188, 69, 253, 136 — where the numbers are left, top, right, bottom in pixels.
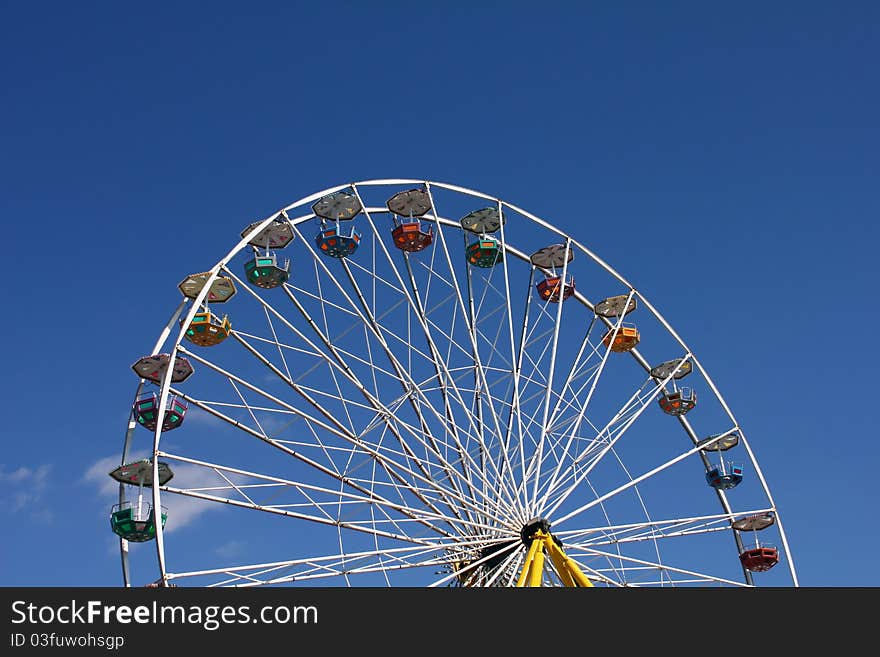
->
0, 2, 880, 586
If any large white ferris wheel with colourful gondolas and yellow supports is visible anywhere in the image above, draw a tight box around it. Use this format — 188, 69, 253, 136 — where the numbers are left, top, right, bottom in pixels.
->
110, 179, 798, 587
